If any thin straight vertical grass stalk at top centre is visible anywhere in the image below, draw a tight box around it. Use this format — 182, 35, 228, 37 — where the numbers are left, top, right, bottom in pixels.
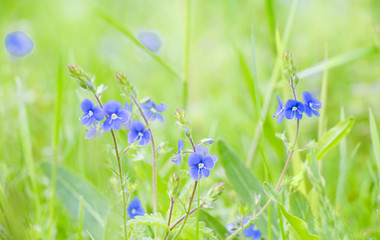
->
182, 0, 191, 110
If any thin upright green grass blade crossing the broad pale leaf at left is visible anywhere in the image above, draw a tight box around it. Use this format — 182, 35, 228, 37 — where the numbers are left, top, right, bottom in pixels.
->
48, 58, 63, 239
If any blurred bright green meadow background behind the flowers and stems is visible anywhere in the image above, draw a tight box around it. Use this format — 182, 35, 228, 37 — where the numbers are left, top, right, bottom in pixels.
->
0, 0, 380, 239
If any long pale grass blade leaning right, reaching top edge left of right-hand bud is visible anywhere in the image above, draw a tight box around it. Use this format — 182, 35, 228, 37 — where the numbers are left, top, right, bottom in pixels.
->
247, 0, 298, 166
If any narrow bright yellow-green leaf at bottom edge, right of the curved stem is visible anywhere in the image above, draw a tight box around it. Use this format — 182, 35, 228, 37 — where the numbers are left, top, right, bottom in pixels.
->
264, 183, 320, 240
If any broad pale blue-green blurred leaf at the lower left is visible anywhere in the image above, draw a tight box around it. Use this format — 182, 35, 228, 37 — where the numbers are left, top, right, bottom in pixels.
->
42, 163, 109, 239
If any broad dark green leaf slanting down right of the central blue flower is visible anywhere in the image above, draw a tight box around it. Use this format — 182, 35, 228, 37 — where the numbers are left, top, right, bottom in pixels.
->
217, 139, 262, 204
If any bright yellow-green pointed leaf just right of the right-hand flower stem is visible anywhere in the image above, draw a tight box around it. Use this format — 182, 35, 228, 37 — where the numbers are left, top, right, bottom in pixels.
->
316, 117, 355, 160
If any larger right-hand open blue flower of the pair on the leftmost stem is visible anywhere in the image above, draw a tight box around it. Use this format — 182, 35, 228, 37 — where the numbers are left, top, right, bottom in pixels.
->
103, 100, 131, 131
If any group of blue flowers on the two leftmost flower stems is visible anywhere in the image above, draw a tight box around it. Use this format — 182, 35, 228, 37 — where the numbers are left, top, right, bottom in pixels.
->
80, 99, 167, 145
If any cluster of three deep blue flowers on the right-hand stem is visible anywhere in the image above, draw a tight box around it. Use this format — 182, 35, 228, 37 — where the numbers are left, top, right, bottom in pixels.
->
273, 91, 322, 123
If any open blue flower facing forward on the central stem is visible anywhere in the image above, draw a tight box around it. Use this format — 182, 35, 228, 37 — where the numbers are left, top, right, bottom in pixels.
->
187, 146, 218, 181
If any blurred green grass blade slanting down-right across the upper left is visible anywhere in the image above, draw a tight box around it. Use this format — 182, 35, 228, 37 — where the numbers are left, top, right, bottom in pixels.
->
93, 7, 180, 78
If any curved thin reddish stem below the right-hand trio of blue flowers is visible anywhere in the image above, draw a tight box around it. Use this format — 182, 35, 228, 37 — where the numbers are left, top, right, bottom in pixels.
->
226, 119, 300, 240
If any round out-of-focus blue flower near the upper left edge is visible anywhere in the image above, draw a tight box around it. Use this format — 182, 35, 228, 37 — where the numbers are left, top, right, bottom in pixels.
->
5, 31, 34, 57
